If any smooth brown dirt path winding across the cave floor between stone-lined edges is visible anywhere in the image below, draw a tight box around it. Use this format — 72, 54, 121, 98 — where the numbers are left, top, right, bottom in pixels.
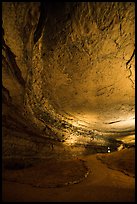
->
3, 150, 135, 202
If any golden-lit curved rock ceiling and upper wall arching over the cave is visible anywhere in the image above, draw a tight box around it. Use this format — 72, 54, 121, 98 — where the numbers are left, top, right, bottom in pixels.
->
2, 2, 135, 145
